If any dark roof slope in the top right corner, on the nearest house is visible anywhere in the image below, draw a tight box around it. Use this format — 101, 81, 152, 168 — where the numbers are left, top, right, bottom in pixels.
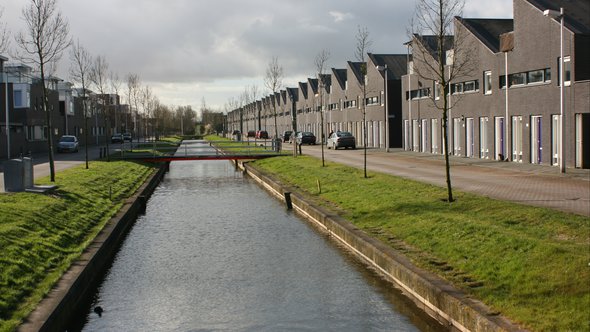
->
525, 0, 590, 35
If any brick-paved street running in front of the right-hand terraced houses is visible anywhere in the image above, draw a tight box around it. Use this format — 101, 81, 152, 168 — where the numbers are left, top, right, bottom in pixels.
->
298, 144, 590, 216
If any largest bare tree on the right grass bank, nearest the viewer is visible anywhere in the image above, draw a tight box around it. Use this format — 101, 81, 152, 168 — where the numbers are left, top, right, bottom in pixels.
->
408, 0, 472, 202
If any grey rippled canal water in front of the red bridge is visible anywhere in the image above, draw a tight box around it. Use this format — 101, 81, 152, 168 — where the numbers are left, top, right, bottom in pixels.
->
72, 141, 443, 331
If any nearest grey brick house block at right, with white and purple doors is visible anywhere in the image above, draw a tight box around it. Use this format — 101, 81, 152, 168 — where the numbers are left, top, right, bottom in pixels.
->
402, 0, 590, 168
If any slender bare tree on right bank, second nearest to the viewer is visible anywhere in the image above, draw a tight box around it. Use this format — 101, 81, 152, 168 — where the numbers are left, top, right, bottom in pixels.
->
354, 26, 373, 178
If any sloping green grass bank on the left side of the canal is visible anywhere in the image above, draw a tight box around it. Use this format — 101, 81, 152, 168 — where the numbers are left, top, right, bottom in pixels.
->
0, 161, 155, 331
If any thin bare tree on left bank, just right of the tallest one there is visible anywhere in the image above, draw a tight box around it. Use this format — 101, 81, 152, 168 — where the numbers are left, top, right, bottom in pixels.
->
70, 40, 92, 169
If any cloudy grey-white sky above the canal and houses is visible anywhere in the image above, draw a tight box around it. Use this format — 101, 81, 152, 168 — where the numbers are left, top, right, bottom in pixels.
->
0, 0, 512, 110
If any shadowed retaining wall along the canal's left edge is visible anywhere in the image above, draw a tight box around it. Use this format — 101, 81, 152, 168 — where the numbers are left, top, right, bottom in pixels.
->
18, 163, 168, 332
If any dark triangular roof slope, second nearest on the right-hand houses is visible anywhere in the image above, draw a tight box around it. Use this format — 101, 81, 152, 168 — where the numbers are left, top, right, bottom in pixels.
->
457, 17, 514, 53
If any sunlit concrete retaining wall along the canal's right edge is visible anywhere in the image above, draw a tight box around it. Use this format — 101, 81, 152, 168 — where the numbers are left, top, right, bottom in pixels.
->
242, 163, 522, 332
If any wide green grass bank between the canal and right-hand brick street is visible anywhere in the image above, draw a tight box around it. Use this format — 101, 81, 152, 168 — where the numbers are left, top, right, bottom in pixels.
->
251, 156, 590, 331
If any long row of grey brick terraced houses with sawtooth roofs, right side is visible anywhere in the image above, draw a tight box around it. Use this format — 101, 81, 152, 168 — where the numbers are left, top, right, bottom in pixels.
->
227, 0, 590, 168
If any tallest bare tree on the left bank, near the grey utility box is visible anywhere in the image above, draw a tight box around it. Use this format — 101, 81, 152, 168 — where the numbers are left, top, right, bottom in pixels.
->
16, 0, 71, 182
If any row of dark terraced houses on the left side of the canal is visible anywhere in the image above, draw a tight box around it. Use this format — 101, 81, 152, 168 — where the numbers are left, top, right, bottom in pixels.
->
0, 60, 149, 159
